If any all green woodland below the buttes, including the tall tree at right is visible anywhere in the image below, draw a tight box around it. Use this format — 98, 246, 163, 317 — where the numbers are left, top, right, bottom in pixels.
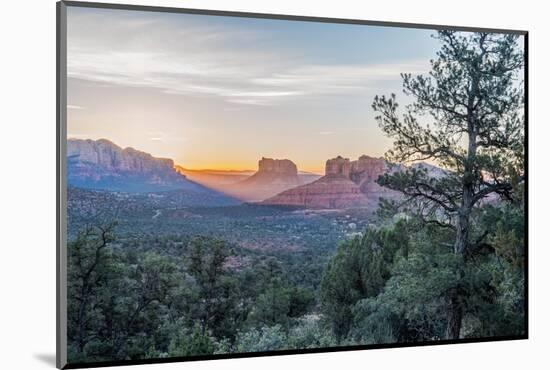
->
67, 31, 526, 363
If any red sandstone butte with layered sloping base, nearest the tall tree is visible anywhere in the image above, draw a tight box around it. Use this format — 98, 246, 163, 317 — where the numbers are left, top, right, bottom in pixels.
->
262, 155, 398, 208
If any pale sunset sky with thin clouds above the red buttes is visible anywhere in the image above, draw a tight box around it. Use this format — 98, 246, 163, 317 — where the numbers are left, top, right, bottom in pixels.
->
67, 7, 444, 173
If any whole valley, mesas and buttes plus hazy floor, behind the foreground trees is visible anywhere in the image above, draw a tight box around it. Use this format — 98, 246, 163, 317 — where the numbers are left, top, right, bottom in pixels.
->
68, 139, 398, 253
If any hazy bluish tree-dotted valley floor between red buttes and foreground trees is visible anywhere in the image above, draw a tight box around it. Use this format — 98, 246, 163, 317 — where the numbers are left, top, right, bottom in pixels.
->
68, 188, 372, 251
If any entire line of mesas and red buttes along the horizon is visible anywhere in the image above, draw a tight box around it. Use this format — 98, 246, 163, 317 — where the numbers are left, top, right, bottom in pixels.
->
67, 139, 445, 209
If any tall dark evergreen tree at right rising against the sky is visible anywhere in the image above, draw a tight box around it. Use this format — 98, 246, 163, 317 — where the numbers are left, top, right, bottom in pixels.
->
372, 31, 524, 339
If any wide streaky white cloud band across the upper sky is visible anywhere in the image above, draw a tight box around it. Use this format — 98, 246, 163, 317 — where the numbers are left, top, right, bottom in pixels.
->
67, 7, 428, 106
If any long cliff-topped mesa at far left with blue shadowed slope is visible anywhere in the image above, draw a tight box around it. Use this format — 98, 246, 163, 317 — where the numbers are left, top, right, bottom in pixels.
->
67, 139, 205, 192
